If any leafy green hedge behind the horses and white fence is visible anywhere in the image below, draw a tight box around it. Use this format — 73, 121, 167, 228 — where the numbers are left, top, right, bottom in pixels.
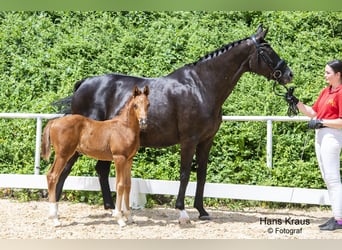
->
0, 11, 342, 204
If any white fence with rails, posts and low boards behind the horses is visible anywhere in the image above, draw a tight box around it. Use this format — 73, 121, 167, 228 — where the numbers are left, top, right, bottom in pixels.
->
0, 113, 330, 207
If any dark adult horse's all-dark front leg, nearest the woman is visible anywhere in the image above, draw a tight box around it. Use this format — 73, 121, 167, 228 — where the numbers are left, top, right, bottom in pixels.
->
194, 138, 213, 220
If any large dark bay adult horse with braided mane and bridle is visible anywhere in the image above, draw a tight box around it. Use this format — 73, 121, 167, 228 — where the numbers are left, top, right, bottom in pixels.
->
57, 25, 292, 223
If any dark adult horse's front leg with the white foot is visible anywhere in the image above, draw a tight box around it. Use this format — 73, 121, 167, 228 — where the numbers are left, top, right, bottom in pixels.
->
176, 143, 195, 224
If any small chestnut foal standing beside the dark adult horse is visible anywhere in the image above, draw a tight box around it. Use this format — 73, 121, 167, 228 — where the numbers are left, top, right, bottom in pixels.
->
42, 86, 149, 226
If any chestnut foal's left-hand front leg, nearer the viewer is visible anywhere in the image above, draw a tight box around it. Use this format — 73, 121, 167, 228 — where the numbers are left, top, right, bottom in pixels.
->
113, 156, 126, 226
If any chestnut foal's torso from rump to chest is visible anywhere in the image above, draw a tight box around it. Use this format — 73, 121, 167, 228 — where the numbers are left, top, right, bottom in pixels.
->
50, 115, 139, 161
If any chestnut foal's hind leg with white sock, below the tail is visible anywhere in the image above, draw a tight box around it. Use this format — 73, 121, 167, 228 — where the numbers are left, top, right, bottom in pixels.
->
46, 156, 66, 226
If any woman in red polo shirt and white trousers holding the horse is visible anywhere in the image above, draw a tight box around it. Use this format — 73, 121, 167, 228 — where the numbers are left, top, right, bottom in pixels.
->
286, 60, 342, 231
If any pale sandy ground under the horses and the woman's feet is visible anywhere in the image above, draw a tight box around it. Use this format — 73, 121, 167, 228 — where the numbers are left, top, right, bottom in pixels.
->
0, 199, 342, 239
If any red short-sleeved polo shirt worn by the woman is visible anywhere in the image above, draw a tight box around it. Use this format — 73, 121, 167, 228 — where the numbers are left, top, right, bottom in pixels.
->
312, 85, 342, 120
